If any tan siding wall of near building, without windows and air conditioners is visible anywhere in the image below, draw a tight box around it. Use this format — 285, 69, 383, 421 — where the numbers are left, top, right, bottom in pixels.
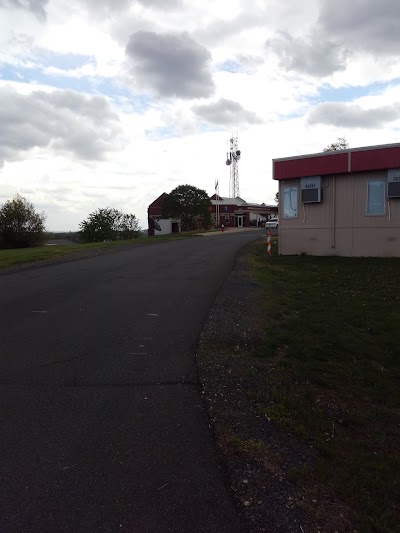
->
279, 170, 400, 257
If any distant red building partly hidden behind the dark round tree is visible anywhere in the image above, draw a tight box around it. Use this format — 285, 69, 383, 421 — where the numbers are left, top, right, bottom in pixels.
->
148, 193, 278, 236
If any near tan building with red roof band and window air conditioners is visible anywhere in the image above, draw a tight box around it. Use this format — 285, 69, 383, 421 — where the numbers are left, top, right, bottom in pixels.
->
273, 144, 400, 257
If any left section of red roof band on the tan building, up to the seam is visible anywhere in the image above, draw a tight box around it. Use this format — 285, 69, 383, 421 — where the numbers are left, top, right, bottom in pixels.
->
273, 152, 348, 180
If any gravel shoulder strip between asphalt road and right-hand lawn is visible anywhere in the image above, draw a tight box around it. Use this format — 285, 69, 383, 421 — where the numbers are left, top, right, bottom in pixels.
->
197, 242, 354, 533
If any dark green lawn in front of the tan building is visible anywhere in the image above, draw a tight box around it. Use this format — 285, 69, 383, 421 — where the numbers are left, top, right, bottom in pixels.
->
250, 241, 400, 532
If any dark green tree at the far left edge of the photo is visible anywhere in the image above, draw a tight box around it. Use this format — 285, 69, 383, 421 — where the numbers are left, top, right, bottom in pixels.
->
0, 195, 46, 248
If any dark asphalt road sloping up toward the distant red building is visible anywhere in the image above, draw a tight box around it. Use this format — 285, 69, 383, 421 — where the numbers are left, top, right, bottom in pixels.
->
0, 231, 262, 533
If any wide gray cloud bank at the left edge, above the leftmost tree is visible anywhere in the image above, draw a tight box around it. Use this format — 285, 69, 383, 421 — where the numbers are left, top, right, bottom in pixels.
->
0, 87, 120, 165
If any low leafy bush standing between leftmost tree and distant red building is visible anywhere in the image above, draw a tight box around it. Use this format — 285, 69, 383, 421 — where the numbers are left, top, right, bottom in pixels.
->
79, 207, 140, 242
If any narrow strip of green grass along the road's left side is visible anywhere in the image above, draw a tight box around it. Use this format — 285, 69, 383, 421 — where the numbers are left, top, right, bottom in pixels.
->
0, 231, 205, 270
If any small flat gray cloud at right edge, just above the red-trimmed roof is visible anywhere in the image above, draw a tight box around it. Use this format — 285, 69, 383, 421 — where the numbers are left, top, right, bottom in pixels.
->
308, 102, 400, 128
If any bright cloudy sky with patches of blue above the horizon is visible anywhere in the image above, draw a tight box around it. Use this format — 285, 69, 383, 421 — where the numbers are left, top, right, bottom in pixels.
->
0, 0, 400, 231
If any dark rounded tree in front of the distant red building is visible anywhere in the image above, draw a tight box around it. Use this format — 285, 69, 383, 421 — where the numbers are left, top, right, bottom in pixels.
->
162, 185, 212, 231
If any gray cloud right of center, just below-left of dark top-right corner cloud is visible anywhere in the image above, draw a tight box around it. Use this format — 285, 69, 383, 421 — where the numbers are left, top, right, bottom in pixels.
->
266, 32, 348, 77
